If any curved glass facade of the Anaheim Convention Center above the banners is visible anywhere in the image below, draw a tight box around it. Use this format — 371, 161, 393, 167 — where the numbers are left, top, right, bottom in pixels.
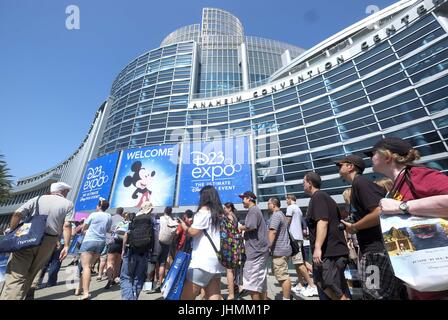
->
2, 1, 448, 220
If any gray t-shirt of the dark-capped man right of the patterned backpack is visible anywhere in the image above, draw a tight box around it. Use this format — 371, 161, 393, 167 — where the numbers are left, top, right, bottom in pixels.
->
244, 206, 269, 260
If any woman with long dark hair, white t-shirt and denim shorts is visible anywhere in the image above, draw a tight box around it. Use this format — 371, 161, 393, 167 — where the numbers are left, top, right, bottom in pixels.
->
180, 186, 225, 300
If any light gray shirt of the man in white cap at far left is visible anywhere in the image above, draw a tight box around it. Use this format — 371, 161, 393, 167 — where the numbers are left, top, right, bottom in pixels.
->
17, 194, 73, 236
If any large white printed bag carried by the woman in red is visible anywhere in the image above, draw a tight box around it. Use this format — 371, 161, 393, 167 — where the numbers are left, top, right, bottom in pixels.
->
381, 215, 448, 291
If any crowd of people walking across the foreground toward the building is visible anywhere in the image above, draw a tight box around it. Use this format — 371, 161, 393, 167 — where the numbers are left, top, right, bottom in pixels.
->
1, 138, 448, 300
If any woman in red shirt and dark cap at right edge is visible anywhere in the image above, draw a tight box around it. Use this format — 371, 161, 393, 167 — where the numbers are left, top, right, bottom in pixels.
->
366, 138, 448, 300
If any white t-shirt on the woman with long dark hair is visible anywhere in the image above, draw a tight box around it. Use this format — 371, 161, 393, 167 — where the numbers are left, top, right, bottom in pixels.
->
189, 209, 226, 273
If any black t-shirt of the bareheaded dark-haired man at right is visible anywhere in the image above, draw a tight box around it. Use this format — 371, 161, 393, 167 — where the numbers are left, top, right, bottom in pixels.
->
306, 190, 348, 258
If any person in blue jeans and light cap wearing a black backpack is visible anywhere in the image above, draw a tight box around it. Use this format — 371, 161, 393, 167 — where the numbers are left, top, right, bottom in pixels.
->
120, 201, 155, 300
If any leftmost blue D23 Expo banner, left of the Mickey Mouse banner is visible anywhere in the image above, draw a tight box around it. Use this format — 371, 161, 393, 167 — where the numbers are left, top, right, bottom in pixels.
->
75, 152, 118, 212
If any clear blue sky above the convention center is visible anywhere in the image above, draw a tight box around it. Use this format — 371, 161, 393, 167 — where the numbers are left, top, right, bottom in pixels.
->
0, 0, 396, 179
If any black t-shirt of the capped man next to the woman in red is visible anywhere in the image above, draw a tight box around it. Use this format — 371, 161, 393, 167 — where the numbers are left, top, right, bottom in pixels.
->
351, 175, 386, 253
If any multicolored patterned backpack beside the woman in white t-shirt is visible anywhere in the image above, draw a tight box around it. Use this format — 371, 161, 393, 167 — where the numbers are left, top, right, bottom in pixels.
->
204, 217, 246, 269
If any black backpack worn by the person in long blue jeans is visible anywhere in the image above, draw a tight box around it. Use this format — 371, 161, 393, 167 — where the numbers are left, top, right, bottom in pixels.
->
129, 214, 154, 253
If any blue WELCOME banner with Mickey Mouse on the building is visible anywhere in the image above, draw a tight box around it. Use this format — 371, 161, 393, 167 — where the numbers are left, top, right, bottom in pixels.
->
112, 145, 179, 208
